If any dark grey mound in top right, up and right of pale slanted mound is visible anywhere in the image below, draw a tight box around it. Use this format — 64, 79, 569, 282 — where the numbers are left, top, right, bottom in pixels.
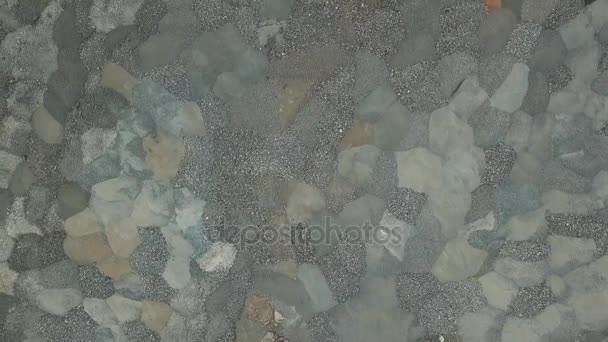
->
528, 30, 567, 74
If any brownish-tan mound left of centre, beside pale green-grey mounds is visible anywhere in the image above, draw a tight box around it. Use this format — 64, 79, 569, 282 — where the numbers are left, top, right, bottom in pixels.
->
143, 134, 185, 183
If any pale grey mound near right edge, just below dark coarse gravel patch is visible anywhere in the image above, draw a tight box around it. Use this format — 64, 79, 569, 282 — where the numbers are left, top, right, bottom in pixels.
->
547, 235, 597, 272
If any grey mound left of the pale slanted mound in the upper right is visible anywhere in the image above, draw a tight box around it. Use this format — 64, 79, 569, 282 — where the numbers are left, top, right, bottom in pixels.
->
439, 52, 477, 98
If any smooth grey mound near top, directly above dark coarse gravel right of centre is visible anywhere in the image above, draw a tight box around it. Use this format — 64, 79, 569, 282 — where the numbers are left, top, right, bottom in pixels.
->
391, 33, 436, 69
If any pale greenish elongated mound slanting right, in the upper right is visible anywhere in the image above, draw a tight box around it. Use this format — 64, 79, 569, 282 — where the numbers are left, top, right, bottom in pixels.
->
490, 63, 530, 113
